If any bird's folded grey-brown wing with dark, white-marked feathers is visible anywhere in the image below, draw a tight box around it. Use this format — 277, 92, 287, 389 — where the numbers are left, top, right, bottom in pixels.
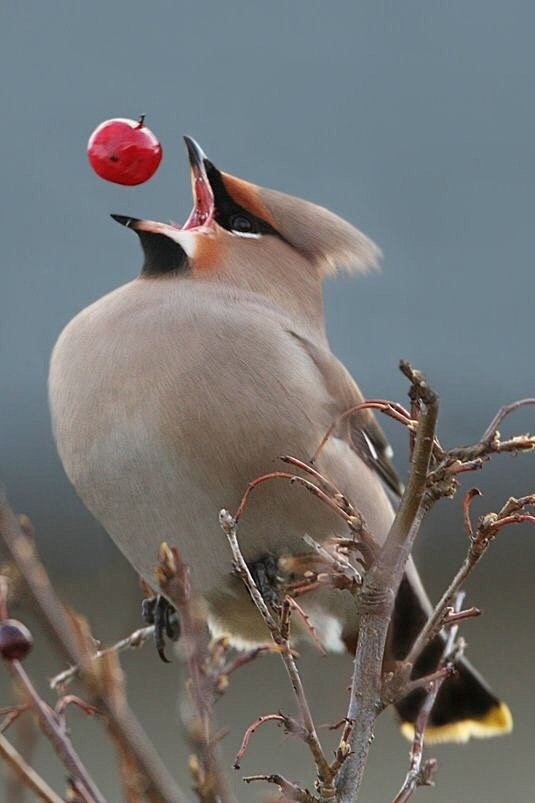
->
290, 331, 403, 497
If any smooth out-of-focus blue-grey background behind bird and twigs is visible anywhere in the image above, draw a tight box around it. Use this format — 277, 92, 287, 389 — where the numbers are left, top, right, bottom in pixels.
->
0, 0, 535, 803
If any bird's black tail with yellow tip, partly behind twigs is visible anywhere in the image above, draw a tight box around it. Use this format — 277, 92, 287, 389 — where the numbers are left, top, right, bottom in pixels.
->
389, 577, 513, 743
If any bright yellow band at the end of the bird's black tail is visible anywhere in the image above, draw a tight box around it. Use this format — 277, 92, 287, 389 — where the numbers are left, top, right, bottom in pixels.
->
401, 703, 513, 744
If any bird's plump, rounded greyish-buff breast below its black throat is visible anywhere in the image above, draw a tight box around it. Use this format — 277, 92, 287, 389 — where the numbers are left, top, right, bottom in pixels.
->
50, 282, 344, 592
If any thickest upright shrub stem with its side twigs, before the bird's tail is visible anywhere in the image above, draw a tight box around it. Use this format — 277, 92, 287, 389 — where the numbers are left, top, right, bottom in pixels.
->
221, 361, 535, 803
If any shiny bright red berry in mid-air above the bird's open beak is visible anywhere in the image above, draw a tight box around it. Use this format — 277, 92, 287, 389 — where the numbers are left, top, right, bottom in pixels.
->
87, 115, 162, 186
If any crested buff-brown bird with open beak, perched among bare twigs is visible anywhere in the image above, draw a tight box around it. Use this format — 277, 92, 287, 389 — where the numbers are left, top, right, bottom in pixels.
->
49, 137, 512, 742
